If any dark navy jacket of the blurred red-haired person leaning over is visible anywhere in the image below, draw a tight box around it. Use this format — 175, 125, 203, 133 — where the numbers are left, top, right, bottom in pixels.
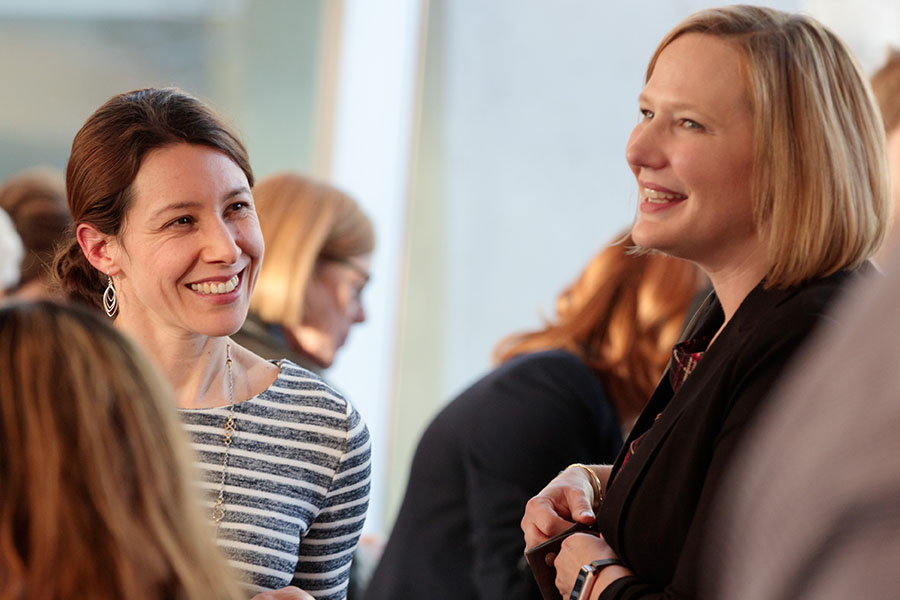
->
365, 351, 622, 600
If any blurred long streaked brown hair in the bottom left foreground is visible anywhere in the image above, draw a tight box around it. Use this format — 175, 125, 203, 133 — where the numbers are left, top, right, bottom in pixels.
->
0, 301, 242, 600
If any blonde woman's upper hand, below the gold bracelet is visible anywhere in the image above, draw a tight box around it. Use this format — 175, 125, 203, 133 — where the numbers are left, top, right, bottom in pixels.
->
521, 467, 610, 548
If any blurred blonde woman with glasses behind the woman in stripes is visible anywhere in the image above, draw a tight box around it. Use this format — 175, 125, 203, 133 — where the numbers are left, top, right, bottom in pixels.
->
240, 173, 375, 370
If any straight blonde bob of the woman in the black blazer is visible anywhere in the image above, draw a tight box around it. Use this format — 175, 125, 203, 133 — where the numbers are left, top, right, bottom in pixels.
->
646, 5, 891, 287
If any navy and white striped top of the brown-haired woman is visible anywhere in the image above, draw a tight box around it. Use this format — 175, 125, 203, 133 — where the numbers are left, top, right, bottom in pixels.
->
180, 360, 370, 600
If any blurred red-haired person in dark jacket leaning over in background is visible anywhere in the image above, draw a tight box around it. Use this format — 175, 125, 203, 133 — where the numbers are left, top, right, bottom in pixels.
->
365, 236, 700, 600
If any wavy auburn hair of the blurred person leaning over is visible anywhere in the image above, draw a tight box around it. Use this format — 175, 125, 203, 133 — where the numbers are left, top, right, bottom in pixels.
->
494, 235, 702, 423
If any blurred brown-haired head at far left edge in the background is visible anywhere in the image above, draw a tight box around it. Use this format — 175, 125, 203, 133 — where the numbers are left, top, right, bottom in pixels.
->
0, 167, 72, 299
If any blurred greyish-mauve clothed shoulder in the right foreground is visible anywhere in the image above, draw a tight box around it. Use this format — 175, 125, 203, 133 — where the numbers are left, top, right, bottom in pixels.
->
701, 237, 900, 600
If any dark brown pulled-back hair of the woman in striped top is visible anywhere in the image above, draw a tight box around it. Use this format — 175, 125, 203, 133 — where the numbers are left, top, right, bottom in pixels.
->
54, 88, 254, 307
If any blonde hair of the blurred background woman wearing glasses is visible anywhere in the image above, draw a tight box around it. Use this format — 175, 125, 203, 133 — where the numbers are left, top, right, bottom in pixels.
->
250, 172, 375, 327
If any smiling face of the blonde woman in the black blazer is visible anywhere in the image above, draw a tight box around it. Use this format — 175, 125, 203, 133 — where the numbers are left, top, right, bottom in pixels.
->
626, 33, 765, 272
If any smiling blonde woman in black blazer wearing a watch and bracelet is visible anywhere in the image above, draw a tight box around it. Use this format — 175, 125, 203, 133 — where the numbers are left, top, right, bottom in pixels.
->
522, 5, 890, 600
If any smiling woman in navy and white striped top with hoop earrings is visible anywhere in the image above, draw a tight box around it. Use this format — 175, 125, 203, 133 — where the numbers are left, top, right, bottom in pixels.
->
56, 88, 370, 600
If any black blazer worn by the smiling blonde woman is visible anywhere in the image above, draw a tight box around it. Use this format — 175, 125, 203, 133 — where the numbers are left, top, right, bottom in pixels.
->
598, 271, 852, 600
